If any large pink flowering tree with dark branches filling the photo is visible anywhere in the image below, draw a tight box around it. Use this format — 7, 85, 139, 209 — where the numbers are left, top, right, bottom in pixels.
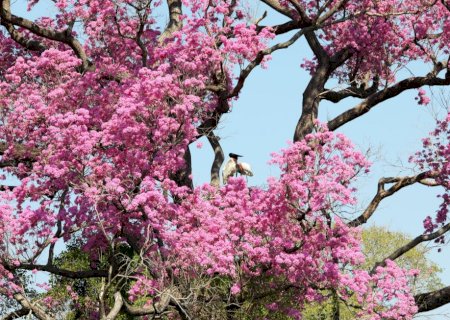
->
0, 0, 450, 320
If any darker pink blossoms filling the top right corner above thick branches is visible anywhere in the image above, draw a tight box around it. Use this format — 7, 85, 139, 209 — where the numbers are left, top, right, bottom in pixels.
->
283, 0, 450, 81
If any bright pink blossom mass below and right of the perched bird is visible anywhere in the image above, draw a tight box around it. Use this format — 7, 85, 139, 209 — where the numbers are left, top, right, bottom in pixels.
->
166, 129, 416, 319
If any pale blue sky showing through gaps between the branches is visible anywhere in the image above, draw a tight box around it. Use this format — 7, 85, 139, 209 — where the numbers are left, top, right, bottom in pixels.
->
8, 1, 450, 319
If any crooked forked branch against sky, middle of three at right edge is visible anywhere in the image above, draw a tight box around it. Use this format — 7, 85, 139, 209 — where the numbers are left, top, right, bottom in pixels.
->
348, 171, 437, 227
